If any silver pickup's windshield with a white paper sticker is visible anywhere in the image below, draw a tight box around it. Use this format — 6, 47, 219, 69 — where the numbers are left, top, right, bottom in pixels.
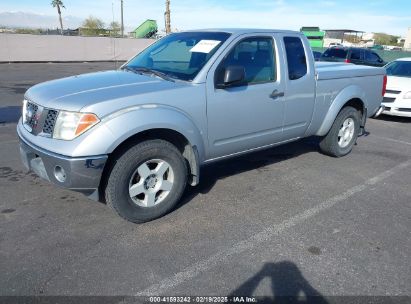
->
123, 32, 230, 81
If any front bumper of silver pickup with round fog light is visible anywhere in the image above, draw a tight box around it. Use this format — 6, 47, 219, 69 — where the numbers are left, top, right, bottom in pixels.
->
19, 134, 108, 200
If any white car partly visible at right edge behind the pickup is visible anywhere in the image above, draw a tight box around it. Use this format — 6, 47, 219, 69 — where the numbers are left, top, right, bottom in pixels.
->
382, 57, 411, 117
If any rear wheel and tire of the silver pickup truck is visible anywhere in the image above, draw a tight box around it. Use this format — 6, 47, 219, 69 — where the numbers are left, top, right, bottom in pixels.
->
320, 106, 360, 157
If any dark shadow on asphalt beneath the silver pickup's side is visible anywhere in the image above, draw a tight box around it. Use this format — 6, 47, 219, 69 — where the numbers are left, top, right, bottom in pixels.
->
176, 137, 319, 209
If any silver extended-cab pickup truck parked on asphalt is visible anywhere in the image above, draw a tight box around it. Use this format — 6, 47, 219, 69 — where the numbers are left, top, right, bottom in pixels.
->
17, 29, 386, 223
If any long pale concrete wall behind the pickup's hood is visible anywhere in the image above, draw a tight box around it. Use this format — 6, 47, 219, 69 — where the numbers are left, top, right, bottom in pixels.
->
0, 34, 154, 62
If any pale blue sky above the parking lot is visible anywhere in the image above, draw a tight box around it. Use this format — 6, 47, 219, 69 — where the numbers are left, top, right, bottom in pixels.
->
0, 0, 411, 35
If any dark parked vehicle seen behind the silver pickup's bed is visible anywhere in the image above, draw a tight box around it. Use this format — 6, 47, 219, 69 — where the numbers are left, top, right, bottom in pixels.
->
320, 47, 386, 67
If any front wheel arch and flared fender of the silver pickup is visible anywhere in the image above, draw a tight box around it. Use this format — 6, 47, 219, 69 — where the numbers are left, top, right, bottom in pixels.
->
99, 106, 205, 197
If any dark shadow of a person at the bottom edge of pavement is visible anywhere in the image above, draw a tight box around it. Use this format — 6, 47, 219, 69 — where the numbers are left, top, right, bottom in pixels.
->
229, 261, 328, 304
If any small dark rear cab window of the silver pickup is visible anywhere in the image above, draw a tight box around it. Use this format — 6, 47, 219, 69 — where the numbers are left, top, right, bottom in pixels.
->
284, 37, 307, 80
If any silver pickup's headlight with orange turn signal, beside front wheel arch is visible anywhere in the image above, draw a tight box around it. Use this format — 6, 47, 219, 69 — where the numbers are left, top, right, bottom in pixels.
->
53, 111, 100, 140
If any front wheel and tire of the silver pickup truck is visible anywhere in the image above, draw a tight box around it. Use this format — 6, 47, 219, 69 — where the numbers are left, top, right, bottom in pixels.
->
105, 139, 187, 223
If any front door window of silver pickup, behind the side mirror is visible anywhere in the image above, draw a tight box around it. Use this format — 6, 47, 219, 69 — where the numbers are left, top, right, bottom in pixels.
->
216, 37, 276, 85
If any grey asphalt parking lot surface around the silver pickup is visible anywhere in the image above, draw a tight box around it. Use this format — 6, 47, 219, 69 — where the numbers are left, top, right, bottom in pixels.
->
0, 63, 411, 303
